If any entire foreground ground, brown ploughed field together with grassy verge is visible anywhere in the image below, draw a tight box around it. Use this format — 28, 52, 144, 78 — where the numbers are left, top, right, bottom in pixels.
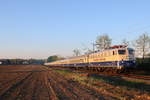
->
0, 65, 150, 100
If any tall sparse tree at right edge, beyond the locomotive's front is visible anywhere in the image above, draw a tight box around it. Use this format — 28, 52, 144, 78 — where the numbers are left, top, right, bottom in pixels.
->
134, 33, 150, 60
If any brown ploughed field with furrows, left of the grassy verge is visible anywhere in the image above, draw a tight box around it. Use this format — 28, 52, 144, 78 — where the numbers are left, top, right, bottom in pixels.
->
0, 65, 106, 100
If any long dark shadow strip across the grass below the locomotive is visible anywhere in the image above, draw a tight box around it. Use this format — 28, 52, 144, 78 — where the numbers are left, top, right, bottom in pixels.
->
89, 74, 150, 92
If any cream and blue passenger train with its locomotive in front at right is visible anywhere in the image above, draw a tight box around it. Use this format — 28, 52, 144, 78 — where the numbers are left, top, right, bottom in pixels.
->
45, 45, 135, 71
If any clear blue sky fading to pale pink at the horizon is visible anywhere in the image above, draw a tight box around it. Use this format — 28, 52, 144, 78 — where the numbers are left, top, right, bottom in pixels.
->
0, 0, 150, 58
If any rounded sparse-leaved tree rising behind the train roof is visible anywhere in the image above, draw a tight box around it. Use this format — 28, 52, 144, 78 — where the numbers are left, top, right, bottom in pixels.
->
96, 34, 112, 50
